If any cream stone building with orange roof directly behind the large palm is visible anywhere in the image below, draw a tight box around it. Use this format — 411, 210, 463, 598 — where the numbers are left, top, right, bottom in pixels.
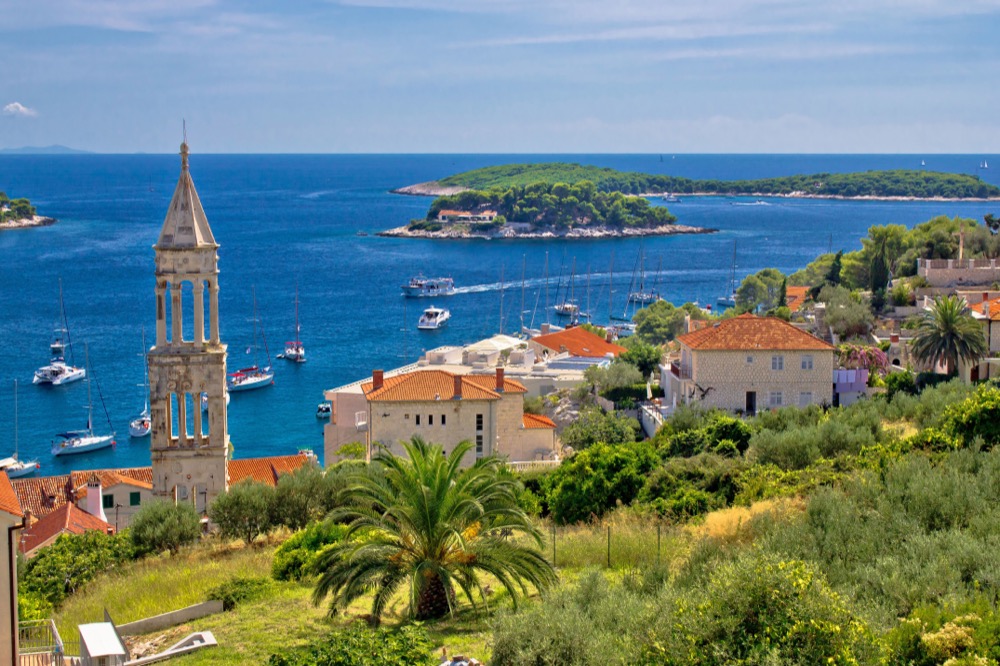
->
324, 368, 557, 466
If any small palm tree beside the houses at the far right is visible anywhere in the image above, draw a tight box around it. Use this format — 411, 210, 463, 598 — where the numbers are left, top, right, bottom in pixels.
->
912, 296, 989, 375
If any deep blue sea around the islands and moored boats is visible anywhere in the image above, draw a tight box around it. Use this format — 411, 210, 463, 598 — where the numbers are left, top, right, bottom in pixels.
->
0, 154, 1000, 475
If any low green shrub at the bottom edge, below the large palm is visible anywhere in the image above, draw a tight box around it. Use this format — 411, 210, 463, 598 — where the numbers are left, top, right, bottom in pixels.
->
267, 625, 437, 666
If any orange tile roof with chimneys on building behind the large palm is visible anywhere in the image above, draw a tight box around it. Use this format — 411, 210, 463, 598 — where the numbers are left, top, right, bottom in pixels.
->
361, 370, 528, 402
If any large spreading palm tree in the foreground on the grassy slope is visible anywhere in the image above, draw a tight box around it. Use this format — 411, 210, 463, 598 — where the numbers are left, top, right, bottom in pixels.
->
313, 437, 556, 624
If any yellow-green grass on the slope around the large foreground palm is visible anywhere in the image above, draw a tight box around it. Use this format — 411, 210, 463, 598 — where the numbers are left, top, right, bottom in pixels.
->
48, 516, 704, 666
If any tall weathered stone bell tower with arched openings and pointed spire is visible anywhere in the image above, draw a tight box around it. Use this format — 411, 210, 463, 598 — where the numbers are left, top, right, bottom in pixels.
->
148, 139, 229, 513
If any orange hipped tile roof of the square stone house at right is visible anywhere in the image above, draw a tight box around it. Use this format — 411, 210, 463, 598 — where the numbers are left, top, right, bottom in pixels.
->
677, 314, 833, 351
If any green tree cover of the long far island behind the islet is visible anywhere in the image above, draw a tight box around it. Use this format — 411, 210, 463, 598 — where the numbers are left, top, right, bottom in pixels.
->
438, 162, 1000, 199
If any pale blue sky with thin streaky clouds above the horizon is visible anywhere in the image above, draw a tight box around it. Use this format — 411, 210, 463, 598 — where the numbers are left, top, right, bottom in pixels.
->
0, 0, 1000, 154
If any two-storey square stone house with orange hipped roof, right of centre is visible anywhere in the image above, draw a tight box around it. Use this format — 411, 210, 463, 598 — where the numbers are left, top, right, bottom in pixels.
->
661, 314, 834, 414
